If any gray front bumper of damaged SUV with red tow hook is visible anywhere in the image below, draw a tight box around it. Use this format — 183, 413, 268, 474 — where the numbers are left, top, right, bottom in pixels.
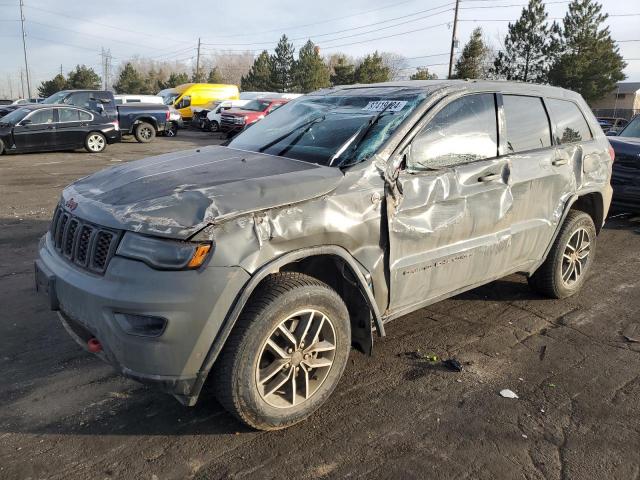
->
35, 234, 249, 405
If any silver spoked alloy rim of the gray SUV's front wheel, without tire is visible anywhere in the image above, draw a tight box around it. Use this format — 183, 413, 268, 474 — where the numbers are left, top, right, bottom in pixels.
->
255, 310, 336, 408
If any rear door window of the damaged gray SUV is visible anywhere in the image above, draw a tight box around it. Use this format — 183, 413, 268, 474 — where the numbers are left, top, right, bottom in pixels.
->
502, 95, 551, 153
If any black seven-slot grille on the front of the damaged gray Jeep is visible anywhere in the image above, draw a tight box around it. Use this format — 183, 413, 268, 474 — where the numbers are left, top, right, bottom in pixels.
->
50, 207, 120, 274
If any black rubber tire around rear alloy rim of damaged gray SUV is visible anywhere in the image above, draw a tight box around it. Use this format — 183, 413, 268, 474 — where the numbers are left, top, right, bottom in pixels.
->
528, 210, 596, 298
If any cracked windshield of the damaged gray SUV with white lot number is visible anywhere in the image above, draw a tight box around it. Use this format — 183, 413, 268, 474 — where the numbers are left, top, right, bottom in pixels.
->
229, 88, 426, 167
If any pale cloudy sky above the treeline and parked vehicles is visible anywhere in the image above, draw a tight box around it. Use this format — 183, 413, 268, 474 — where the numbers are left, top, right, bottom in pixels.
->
0, 0, 640, 97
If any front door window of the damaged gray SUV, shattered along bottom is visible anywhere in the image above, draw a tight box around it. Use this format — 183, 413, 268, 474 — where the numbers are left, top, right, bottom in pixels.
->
408, 93, 498, 170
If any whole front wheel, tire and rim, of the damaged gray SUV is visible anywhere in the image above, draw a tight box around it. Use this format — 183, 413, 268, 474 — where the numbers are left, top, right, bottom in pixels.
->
214, 272, 351, 430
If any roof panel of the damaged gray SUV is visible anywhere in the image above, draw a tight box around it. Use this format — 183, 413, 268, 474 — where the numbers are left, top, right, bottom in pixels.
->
316, 80, 580, 99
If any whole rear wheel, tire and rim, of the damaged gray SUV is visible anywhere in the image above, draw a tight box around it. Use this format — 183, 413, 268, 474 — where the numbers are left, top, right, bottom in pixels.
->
529, 210, 596, 298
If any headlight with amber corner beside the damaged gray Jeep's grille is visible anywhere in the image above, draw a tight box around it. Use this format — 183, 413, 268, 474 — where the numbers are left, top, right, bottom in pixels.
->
116, 232, 212, 270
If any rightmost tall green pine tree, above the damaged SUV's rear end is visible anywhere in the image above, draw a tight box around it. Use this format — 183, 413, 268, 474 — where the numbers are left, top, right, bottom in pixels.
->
549, 0, 626, 102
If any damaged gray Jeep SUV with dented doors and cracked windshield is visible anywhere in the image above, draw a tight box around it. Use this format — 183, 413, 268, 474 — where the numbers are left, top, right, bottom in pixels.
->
36, 81, 613, 430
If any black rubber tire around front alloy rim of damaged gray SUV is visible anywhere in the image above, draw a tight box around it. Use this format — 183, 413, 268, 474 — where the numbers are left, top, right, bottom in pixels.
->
213, 272, 351, 430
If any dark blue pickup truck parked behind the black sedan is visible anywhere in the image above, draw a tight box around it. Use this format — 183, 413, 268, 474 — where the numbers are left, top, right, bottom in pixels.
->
42, 90, 170, 143
